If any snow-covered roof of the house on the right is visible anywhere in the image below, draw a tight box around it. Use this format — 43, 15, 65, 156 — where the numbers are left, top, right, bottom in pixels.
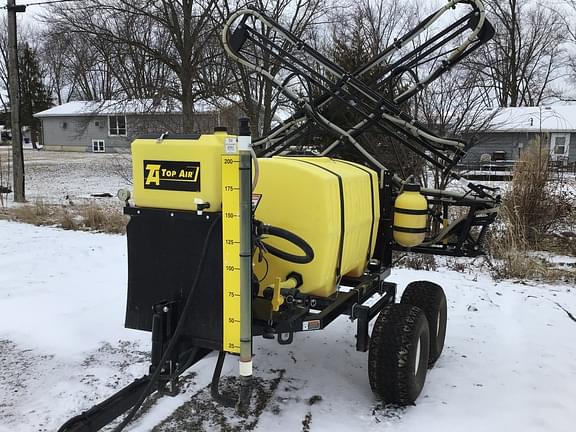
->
487, 105, 576, 132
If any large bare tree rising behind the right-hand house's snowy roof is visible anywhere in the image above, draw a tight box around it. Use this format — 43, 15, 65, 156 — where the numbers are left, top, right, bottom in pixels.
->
471, 0, 566, 107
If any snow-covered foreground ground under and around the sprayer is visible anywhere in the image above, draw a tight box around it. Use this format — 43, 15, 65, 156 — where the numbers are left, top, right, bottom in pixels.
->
0, 221, 576, 432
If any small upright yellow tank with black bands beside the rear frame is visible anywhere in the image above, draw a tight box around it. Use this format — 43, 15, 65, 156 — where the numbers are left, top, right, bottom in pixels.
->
394, 183, 428, 247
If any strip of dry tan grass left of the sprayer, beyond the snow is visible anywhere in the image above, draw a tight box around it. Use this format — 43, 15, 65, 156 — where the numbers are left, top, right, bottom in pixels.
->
0, 200, 128, 234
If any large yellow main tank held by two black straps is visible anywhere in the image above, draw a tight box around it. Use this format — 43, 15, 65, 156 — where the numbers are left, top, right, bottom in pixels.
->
254, 157, 380, 297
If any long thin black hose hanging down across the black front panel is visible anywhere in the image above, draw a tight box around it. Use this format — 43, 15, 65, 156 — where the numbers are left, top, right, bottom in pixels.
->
113, 215, 221, 432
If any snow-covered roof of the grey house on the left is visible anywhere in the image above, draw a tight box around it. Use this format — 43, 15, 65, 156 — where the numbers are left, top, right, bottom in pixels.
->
34, 99, 221, 118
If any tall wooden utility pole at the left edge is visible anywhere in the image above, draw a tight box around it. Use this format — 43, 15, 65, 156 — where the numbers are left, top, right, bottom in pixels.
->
6, 0, 26, 202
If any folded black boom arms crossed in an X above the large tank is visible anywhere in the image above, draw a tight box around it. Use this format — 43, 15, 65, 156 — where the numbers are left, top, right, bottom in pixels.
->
223, 0, 493, 174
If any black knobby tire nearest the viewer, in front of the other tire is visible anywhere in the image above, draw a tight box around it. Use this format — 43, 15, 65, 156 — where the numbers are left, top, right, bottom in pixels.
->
368, 304, 429, 406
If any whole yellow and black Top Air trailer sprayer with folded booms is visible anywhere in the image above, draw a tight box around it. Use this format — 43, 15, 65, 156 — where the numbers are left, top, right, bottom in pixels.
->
60, 0, 499, 432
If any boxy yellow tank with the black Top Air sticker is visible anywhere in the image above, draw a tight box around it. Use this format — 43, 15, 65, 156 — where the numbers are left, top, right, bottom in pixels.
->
132, 130, 233, 212
